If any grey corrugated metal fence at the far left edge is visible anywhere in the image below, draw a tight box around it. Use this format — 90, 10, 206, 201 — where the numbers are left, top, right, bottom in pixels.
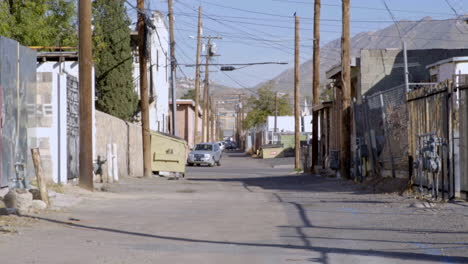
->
0, 37, 36, 187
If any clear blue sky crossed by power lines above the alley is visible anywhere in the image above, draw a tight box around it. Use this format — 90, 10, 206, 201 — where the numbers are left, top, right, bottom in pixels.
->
129, 0, 468, 87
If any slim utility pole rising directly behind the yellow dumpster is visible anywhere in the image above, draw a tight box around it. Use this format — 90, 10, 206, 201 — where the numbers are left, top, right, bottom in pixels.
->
167, 0, 177, 136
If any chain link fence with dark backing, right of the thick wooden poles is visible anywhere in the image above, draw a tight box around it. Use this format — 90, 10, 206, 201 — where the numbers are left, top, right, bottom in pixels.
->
353, 85, 408, 177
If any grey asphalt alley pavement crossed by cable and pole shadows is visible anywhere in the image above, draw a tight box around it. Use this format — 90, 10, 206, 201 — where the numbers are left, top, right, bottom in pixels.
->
0, 153, 468, 264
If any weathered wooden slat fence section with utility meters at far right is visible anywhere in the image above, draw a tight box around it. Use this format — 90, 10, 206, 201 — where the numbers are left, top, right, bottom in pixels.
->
407, 81, 461, 199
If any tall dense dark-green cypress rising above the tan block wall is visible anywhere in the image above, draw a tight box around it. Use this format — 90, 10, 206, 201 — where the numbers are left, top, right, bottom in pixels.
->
93, 0, 138, 120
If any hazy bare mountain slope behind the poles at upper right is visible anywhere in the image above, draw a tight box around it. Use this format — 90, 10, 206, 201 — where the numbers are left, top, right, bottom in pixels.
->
256, 17, 468, 95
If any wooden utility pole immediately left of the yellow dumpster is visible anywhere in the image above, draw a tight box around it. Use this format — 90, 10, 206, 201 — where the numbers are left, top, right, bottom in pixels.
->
137, 0, 152, 177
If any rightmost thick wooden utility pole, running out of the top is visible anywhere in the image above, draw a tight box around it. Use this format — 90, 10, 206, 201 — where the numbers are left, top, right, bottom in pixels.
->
340, 0, 351, 178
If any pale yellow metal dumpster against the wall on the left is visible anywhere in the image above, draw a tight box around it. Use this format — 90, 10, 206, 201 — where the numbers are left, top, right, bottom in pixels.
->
151, 132, 188, 175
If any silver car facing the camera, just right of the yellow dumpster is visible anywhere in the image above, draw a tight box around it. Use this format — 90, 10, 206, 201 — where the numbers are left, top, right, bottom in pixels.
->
187, 143, 222, 167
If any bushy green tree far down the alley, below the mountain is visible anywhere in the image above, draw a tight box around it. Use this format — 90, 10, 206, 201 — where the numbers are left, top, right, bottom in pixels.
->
244, 82, 292, 128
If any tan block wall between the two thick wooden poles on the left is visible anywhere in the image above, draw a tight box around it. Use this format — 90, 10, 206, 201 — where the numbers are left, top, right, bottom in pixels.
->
96, 111, 143, 178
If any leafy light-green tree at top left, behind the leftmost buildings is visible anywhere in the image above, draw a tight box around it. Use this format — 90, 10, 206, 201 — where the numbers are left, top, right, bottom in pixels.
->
0, 0, 78, 46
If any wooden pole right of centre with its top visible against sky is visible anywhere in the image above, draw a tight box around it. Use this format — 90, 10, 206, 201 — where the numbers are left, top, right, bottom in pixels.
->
294, 16, 301, 169
